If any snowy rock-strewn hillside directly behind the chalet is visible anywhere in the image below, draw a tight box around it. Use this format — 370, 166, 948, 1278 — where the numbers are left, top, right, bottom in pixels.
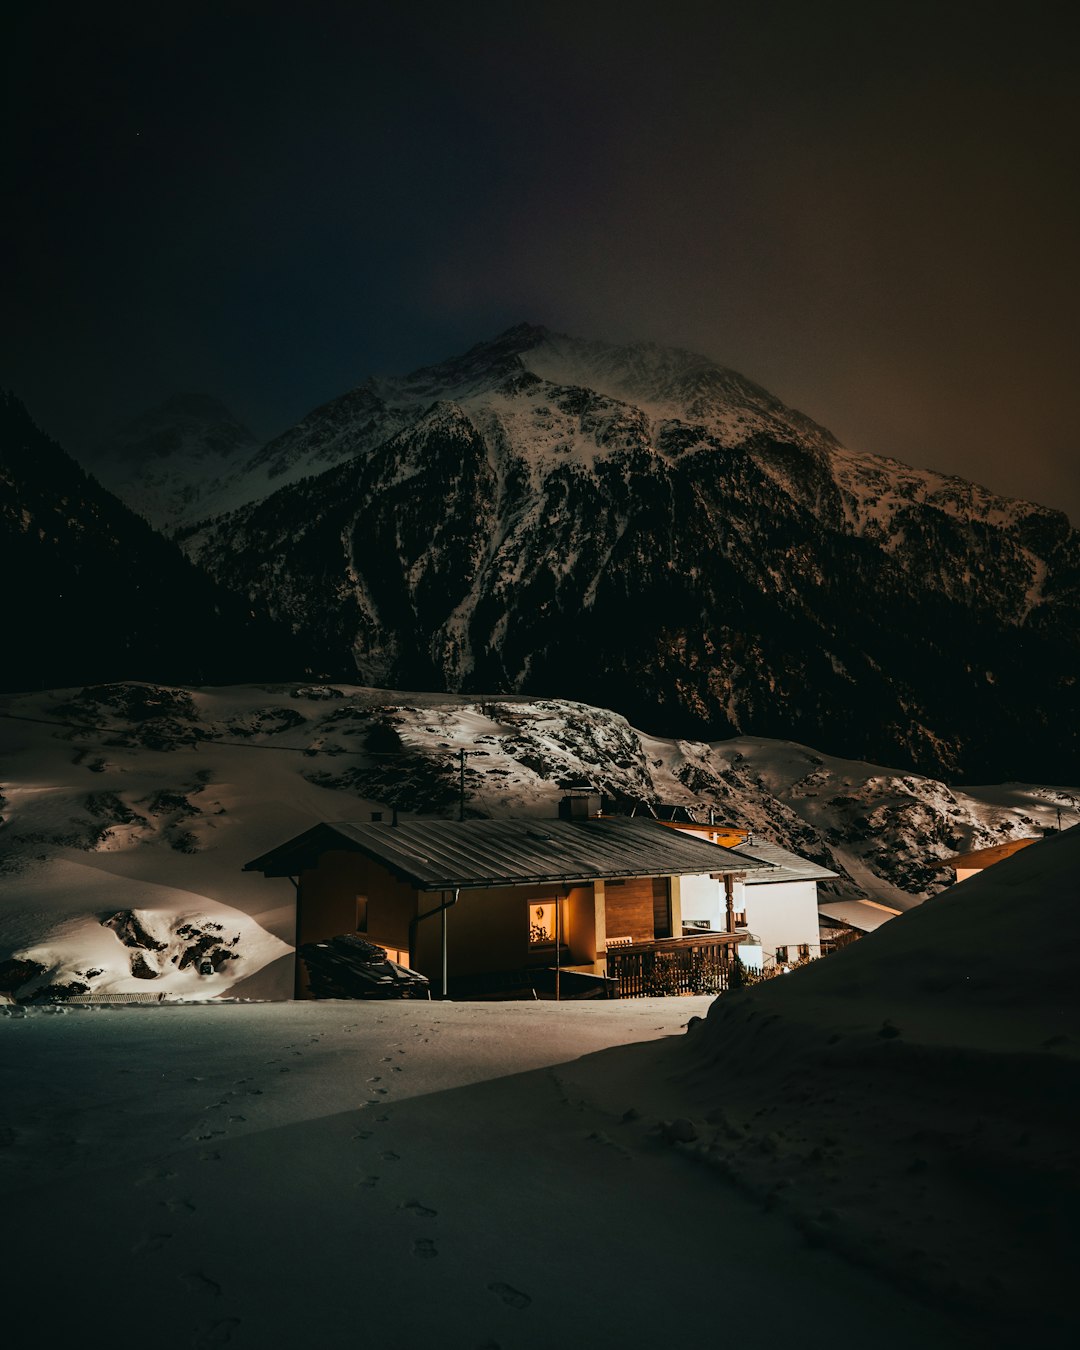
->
0, 683, 1080, 998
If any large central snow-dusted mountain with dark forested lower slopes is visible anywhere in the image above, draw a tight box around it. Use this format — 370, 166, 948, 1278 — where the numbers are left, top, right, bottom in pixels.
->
151, 325, 1080, 780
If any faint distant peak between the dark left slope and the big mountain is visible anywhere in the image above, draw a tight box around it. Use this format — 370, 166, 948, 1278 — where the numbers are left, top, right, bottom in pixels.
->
88, 394, 259, 531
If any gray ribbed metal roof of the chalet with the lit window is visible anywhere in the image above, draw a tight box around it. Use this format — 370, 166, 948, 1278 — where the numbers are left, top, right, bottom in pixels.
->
244, 817, 772, 891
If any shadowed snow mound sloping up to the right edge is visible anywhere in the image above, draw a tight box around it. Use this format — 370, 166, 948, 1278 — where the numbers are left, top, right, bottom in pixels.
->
682, 828, 1080, 1345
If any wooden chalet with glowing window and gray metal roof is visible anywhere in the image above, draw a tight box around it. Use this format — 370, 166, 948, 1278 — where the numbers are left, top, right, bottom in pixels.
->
244, 799, 772, 996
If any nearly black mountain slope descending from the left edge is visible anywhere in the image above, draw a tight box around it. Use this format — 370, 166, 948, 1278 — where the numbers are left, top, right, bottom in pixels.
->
0, 393, 312, 690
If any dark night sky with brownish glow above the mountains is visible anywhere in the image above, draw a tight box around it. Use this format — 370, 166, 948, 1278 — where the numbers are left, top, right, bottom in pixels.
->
8, 0, 1080, 522
